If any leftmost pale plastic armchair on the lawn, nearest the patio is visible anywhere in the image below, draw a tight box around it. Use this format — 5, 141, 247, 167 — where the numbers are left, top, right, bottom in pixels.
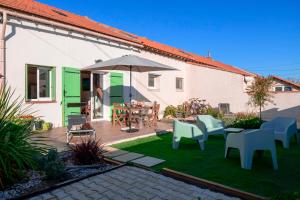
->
172, 120, 205, 150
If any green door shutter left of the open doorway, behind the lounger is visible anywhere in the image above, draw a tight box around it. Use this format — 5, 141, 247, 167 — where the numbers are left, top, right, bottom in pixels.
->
62, 67, 80, 126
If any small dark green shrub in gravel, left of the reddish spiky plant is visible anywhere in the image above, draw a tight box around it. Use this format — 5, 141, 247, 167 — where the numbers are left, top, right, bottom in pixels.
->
35, 149, 66, 180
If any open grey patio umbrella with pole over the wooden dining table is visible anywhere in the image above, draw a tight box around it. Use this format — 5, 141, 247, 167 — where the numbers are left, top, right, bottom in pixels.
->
83, 55, 177, 132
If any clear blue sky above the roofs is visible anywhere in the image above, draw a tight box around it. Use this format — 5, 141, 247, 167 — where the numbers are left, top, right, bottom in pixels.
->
38, 0, 300, 79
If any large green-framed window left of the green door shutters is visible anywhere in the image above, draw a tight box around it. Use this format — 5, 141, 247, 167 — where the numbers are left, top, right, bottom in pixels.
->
26, 65, 55, 101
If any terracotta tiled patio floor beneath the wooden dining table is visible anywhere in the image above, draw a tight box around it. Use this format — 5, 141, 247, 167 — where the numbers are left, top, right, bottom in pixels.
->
38, 121, 172, 151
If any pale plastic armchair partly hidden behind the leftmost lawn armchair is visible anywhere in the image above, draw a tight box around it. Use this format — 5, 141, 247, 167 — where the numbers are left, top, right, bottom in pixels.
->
197, 115, 226, 139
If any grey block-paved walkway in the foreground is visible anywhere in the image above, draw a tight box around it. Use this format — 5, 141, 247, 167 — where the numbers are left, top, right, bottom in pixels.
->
31, 166, 237, 200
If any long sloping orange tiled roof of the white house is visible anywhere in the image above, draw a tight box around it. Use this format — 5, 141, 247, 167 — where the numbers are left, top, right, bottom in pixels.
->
0, 0, 254, 76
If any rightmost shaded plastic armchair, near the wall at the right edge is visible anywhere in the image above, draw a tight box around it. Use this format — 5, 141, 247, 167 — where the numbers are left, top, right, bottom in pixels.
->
260, 117, 300, 148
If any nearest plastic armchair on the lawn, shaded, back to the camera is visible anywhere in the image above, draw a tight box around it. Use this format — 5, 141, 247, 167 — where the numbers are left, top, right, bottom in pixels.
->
225, 128, 278, 170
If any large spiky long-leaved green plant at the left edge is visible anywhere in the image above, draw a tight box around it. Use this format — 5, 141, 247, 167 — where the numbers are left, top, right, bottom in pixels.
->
0, 84, 46, 188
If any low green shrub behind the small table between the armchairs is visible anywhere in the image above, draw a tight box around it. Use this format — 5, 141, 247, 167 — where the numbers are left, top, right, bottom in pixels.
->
231, 113, 263, 129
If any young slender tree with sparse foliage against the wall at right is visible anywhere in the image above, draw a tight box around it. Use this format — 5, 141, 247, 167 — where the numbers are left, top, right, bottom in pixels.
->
247, 76, 274, 119
